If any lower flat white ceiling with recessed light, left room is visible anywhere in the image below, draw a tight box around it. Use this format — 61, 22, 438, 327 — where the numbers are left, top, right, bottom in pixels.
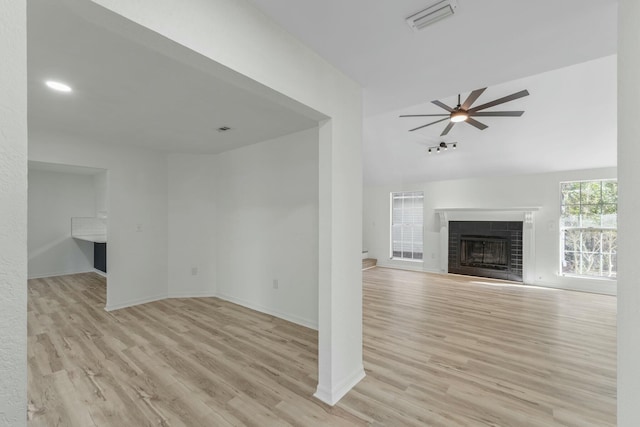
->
28, 0, 317, 153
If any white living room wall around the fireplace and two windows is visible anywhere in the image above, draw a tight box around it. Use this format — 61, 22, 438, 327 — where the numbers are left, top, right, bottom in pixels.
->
363, 168, 616, 294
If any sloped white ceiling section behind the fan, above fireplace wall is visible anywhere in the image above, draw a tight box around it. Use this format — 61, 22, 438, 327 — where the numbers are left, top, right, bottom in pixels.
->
364, 55, 617, 185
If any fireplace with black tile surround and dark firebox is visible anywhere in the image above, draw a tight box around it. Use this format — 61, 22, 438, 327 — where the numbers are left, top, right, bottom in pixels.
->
449, 221, 522, 282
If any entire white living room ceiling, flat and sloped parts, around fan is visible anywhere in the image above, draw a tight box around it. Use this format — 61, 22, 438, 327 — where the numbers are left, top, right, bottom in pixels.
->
251, 0, 617, 185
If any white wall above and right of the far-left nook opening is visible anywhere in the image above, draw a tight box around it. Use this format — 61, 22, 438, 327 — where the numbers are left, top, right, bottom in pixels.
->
29, 133, 168, 309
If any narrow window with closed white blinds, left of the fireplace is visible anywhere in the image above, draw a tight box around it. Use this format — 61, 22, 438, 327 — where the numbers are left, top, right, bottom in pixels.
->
391, 191, 424, 260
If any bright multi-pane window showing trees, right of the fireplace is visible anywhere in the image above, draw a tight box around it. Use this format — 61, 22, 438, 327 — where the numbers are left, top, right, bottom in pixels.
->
560, 180, 618, 278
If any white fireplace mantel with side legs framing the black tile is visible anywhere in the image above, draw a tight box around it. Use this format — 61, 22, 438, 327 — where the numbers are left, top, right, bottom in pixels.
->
435, 206, 540, 283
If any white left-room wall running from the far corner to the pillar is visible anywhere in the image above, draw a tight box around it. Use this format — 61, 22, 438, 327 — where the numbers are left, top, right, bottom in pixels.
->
216, 129, 318, 328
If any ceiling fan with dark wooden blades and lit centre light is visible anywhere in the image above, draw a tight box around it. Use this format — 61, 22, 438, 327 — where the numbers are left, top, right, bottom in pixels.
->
400, 87, 529, 136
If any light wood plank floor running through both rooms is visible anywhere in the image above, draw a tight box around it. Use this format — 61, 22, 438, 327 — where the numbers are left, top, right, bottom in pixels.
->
28, 267, 616, 427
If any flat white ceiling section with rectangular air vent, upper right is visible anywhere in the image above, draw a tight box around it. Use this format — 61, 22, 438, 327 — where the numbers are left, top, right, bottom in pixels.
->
251, 0, 618, 115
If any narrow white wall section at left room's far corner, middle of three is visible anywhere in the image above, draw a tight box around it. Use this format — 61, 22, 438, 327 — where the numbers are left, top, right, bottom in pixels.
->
168, 154, 221, 297
